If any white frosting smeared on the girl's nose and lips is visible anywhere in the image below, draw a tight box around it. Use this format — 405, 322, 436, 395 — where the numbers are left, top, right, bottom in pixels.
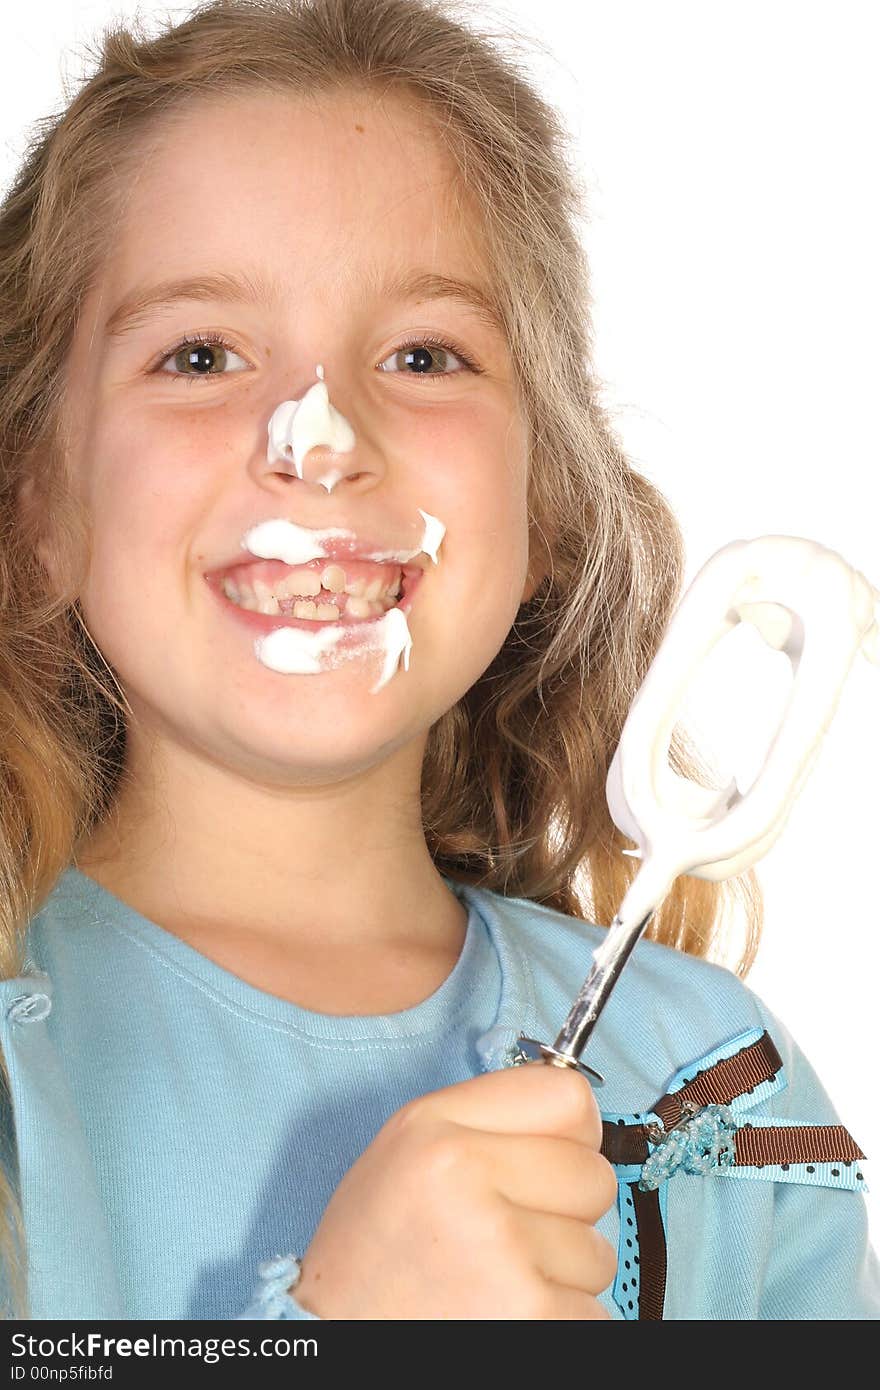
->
241, 364, 446, 695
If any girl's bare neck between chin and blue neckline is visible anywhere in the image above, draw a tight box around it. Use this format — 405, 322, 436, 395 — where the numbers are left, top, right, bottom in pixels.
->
75, 728, 467, 954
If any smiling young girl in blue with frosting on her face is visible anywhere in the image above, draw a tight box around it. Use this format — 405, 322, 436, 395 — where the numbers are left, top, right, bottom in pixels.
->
0, 0, 880, 1319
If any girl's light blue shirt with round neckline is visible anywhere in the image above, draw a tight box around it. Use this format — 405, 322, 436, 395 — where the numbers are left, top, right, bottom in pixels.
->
0, 866, 880, 1321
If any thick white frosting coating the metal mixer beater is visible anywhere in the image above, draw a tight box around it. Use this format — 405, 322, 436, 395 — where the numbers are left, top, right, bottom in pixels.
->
596, 535, 880, 939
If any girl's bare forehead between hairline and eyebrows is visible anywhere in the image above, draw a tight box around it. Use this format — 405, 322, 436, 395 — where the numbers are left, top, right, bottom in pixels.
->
108, 93, 482, 289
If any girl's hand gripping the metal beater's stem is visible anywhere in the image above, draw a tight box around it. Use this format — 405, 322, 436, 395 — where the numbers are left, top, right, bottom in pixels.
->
293, 1062, 617, 1319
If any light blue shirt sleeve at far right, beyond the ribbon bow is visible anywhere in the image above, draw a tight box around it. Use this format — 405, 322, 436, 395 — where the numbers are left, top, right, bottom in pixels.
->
755, 997, 880, 1321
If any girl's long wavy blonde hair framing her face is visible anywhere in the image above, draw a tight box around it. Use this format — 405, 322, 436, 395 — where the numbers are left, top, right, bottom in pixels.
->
0, 0, 763, 1316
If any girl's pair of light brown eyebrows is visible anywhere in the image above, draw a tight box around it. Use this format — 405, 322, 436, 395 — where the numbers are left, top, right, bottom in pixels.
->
104, 270, 503, 338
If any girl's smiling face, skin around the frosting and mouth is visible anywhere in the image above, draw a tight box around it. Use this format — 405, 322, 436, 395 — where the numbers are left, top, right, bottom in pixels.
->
58, 95, 531, 795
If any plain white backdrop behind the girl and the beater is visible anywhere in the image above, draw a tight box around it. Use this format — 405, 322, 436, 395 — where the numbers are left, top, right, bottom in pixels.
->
0, 0, 880, 1244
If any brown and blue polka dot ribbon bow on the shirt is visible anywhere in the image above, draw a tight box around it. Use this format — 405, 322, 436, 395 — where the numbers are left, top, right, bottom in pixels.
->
602, 1031, 865, 1322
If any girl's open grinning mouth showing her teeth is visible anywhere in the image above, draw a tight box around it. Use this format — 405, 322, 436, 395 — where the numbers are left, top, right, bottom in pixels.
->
204, 560, 424, 632
